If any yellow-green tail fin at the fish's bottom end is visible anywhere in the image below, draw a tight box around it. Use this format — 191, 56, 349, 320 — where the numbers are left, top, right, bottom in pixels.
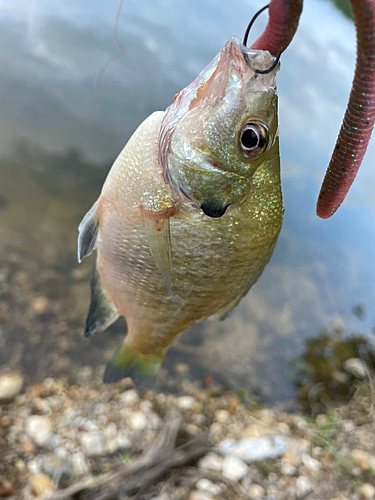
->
103, 342, 163, 388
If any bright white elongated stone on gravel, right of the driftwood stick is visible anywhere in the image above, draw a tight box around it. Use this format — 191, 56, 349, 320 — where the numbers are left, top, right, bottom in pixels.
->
219, 435, 288, 463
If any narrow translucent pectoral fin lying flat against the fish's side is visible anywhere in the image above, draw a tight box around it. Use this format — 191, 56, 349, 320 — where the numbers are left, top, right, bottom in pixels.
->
142, 210, 172, 296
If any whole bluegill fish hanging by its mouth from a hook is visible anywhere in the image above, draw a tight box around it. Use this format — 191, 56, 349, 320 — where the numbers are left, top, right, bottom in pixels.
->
78, 38, 283, 386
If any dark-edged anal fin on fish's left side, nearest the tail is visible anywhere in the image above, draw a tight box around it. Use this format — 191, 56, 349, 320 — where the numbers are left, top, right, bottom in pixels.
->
85, 270, 119, 337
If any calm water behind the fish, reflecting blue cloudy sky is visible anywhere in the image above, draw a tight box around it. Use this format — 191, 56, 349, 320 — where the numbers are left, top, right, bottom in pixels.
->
0, 0, 375, 401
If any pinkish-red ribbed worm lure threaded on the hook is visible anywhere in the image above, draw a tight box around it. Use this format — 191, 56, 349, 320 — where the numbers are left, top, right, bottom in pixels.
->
252, 0, 375, 219
